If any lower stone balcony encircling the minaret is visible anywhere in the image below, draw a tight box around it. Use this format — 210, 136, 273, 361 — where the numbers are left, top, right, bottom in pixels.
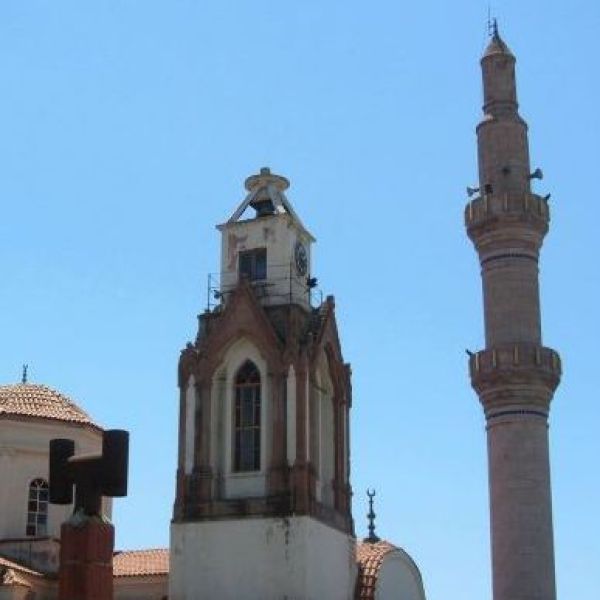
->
469, 343, 562, 405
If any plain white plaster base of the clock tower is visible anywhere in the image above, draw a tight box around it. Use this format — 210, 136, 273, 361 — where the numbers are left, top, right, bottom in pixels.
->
169, 517, 356, 600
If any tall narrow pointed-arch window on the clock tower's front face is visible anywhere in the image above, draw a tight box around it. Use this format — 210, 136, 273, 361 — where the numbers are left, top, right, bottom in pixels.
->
233, 360, 260, 472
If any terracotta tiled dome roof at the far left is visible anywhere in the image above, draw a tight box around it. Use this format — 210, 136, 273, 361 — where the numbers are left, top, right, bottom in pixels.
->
0, 383, 99, 429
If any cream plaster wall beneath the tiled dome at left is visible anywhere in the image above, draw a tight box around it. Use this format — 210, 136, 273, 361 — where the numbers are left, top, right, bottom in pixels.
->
0, 419, 106, 539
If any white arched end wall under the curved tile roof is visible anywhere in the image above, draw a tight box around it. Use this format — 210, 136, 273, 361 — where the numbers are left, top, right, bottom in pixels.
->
375, 549, 425, 600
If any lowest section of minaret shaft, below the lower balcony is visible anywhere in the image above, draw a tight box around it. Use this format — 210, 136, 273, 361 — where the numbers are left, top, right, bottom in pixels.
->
487, 415, 556, 600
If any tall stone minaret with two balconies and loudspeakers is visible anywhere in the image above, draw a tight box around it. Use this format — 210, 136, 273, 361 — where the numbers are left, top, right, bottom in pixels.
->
465, 27, 561, 600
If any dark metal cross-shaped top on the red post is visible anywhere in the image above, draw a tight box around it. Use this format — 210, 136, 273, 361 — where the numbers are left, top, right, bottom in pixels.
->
49, 429, 129, 516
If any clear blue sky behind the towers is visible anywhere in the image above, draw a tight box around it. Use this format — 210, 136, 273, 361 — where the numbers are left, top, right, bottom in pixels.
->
0, 0, 600, 600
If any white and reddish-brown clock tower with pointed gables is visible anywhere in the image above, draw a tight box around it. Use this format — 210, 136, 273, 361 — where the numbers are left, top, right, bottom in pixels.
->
169, 169, 356, 600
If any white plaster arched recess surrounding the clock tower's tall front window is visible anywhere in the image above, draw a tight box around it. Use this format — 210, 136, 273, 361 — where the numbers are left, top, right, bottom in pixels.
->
211, 338, 271, 498
